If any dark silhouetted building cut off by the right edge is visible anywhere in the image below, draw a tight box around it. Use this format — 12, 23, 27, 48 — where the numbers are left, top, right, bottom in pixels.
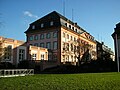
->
112, 23, 120, 62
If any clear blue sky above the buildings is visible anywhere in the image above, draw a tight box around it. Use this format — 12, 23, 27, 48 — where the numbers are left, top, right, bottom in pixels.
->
0, 0, 120, 49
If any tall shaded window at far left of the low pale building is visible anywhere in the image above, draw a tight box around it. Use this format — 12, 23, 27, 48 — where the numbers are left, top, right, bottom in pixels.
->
4, 45, 12, 61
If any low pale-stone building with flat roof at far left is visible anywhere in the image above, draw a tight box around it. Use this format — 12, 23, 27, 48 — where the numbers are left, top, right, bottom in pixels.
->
0, 37, 48, 66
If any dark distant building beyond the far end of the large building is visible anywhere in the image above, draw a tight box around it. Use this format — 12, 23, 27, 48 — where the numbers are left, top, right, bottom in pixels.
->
96, 41, 114, 61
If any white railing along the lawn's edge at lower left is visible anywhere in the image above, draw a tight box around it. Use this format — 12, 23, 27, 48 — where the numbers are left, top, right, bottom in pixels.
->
0, 69, 34, 77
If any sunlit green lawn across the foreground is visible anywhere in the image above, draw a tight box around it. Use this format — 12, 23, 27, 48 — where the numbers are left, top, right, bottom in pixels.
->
0, 73, 120, 90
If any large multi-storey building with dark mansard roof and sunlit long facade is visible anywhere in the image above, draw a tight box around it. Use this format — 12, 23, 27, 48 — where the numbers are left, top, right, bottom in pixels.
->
25, 11, 96, 65
